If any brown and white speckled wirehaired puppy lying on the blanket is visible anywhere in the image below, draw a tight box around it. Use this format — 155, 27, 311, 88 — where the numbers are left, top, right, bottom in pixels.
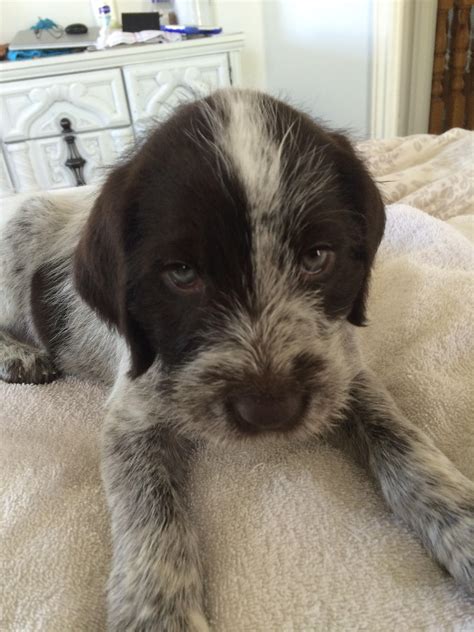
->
0, 90, 474, 632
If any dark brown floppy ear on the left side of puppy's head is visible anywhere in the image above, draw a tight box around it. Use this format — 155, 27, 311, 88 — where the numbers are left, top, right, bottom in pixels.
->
74, 164, 155, 377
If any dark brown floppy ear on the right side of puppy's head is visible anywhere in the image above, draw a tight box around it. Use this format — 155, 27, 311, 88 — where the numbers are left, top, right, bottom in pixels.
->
331, 133, 385, 327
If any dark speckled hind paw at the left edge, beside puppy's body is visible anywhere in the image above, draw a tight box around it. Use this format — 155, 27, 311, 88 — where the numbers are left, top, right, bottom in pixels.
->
0, 345, 59, 384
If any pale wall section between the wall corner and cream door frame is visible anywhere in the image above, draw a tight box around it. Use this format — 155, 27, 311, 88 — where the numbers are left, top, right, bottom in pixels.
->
263, 0, 372, 138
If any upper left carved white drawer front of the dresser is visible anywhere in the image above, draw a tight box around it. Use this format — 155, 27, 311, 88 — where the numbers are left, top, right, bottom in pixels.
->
0, 68, 130, 142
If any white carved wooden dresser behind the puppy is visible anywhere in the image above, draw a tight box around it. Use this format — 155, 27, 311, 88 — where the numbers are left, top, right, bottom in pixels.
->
0, 34, 243, 197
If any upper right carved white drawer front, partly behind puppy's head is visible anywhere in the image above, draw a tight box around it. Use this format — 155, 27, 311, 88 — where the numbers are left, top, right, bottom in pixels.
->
123, 54, 231, 129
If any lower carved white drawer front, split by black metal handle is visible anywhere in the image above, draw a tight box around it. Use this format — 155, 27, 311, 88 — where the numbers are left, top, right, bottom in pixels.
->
5, 127, 135, 192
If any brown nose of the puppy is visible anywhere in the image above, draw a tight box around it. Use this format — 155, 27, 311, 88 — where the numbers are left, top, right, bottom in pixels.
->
230, 393, 304, 432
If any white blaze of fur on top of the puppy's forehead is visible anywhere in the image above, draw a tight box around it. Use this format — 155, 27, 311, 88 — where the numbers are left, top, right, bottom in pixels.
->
217, 92, 283, 215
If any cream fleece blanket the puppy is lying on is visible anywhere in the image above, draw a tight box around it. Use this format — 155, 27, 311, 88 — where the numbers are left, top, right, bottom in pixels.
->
0, 134, 474, 632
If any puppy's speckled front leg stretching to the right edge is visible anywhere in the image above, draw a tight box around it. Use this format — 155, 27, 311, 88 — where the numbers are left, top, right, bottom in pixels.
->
352, 372, 474, 590
